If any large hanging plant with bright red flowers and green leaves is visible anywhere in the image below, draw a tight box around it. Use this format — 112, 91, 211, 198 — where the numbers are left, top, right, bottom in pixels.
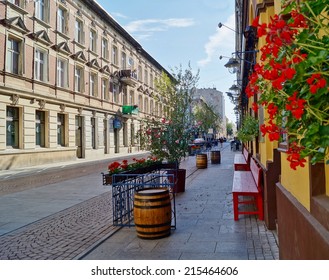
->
246, 0, 329, 169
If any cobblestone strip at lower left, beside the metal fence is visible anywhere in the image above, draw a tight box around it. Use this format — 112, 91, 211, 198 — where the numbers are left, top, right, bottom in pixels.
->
0, 192, 117, 260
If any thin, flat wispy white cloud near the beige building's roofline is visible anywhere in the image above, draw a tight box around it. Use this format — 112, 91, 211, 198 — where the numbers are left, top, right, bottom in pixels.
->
124, 18, 195, 33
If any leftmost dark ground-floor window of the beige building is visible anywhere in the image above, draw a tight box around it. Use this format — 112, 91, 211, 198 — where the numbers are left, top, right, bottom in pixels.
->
6, 106, 19, 148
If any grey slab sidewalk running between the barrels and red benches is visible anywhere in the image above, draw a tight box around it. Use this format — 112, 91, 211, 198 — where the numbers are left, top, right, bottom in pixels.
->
81, 146, 279, 260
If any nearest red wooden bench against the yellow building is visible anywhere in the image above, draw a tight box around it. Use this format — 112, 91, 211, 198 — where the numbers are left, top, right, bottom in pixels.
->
232, 158, 264, 221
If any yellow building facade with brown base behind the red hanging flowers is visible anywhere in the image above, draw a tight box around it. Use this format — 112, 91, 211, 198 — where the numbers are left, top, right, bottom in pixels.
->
236, 0, 329, 259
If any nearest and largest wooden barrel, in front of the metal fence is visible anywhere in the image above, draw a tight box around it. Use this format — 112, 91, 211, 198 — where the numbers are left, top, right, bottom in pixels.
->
134, 188, 171, 239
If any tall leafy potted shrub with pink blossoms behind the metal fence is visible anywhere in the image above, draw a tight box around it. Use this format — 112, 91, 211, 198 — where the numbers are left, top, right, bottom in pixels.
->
138, 65, 198, 192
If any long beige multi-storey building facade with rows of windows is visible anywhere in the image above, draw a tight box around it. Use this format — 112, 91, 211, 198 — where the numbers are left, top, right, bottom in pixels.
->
0, 0, 168, 170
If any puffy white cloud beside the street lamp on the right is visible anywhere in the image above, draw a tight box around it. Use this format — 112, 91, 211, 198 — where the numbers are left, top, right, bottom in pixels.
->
198, 14, 235, 67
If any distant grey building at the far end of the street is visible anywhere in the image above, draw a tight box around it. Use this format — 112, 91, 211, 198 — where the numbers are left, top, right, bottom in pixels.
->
193, 88, 227, 137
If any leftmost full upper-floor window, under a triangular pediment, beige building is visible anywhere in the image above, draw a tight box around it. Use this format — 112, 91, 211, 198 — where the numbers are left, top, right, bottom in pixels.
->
7, 38, 22, 75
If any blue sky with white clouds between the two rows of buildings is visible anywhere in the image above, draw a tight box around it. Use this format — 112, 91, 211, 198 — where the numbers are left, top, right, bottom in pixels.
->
97, 0, 236, 122
